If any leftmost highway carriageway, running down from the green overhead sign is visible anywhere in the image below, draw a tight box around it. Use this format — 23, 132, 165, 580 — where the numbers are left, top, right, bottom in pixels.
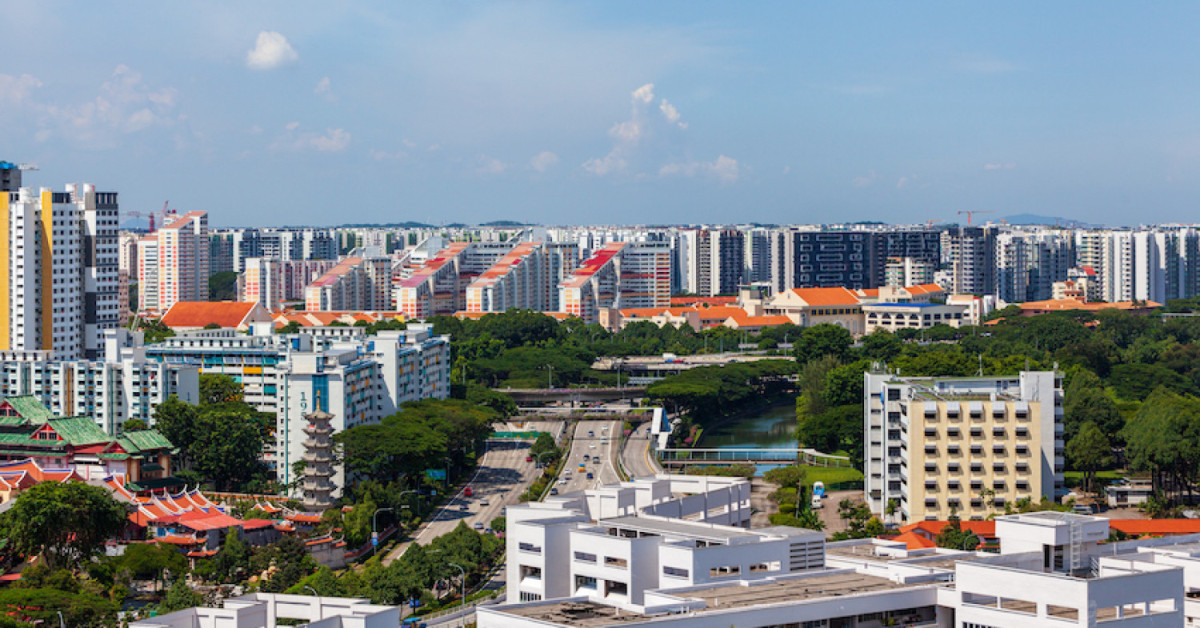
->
383, 434, 540, 564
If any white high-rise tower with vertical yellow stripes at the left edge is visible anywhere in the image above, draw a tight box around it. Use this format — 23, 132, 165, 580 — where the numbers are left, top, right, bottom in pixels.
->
0, 184, 120, 360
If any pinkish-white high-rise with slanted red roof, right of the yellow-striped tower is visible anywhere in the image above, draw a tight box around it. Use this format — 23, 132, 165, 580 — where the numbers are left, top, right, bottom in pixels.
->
138, 211, 210, 311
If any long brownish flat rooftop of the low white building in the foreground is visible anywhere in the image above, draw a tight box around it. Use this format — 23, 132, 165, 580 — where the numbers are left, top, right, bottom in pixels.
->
499, 573, 912, 628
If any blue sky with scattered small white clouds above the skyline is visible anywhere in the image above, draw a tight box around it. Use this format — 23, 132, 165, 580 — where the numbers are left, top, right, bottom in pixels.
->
0, 0, 1200, 226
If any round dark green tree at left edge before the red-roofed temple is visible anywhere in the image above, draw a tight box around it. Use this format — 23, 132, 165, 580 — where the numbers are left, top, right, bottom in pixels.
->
0, 482, 125, 567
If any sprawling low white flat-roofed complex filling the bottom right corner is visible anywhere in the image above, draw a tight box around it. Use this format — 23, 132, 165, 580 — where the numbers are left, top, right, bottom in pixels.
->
476, 513, 1200, 628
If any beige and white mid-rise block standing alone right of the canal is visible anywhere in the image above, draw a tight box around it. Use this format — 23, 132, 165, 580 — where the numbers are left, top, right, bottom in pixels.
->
863, 371, 1063, 522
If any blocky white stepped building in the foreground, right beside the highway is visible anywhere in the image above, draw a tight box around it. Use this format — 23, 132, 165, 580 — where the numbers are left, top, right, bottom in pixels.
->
506, 476, 824, 609
